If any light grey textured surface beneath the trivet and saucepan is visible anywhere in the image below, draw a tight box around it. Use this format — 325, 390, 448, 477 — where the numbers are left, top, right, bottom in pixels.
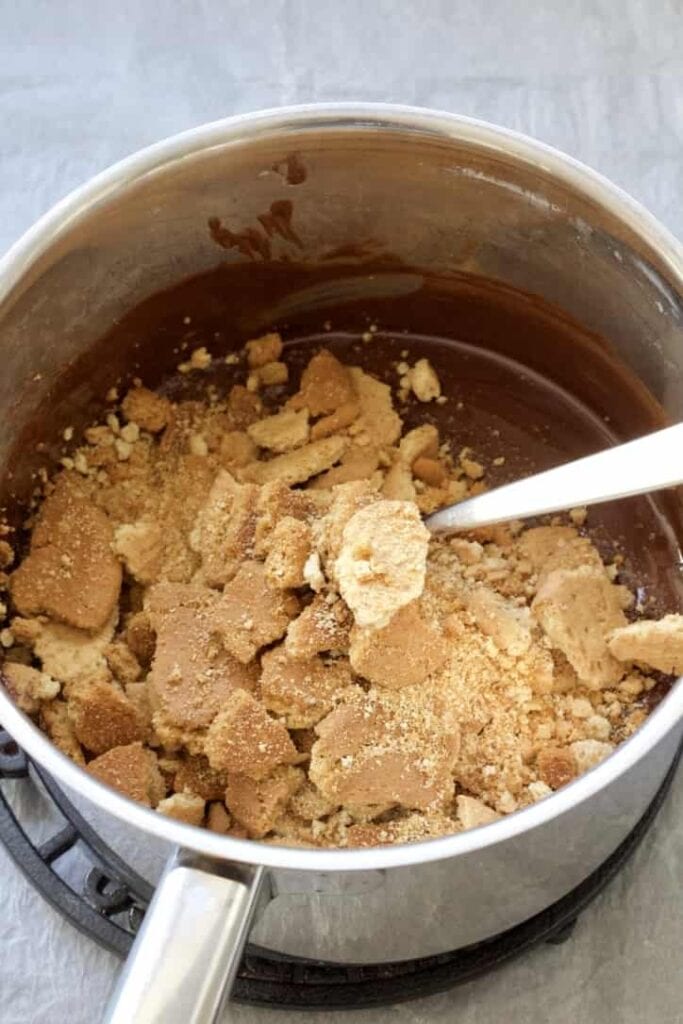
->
0, 0, 683, 1024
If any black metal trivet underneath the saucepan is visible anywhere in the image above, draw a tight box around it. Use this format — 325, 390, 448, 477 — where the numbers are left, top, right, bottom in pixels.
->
0, 729, 681, 1010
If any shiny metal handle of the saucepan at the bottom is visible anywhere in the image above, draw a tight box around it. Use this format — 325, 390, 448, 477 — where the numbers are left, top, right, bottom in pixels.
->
103, 850, 269, 1024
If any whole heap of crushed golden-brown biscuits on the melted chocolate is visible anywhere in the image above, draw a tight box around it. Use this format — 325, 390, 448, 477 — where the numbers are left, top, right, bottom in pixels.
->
0, 329, 683, 848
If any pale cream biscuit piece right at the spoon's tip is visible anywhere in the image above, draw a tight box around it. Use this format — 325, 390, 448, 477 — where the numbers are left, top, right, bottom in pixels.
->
335, 501, 429, 627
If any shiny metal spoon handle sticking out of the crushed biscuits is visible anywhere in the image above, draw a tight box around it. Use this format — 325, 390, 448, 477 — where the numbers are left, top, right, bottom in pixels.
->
425, 423, 683, 534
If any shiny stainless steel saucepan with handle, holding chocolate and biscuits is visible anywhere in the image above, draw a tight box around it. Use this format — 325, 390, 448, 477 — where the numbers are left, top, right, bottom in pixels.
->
0, 104, 683, 1024
